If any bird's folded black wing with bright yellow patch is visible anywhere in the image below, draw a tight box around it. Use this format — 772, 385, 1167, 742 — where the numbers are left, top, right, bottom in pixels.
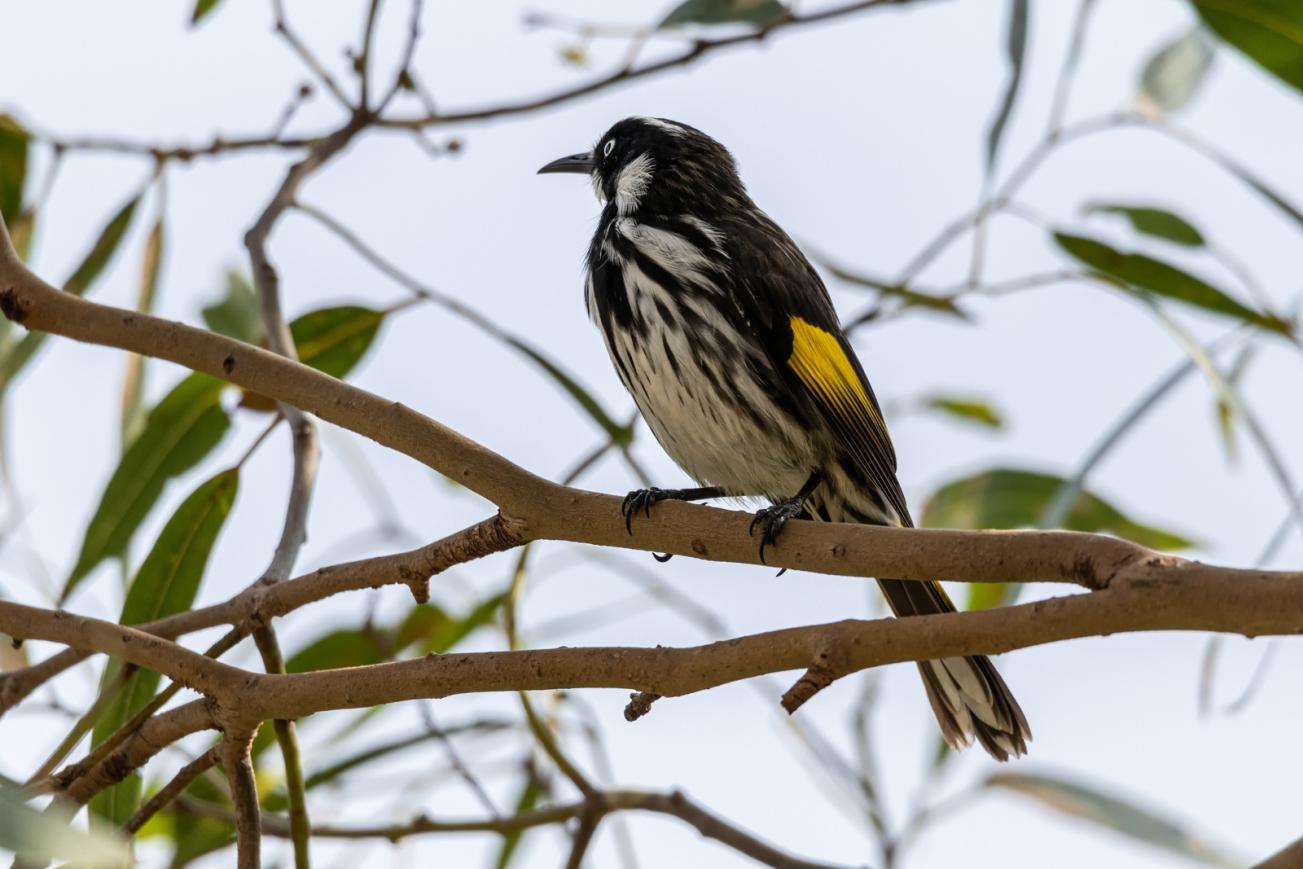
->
735, 213, 911, 525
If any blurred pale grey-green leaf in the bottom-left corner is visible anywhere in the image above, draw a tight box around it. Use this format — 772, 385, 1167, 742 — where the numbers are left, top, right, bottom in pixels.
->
0, 784, 134, 866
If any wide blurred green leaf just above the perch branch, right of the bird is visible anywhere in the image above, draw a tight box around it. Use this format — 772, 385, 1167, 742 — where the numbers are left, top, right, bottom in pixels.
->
923, 468, 1194, 550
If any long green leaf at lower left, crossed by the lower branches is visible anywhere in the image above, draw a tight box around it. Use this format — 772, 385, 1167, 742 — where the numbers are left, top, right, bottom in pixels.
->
91, 468, 240, 826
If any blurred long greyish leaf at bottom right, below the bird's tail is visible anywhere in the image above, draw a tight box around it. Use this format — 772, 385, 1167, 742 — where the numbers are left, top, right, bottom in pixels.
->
986, 773, 1246, 866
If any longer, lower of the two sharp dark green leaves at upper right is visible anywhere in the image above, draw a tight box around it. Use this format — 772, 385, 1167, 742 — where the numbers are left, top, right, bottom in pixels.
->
1054, 232, 1293, 335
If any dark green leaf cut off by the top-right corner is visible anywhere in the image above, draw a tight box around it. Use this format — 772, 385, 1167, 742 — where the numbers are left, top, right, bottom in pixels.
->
1192, 0, 1303, 90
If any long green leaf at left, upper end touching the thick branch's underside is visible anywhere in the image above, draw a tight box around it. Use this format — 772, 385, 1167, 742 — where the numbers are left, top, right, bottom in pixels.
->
60, 374, 231, 601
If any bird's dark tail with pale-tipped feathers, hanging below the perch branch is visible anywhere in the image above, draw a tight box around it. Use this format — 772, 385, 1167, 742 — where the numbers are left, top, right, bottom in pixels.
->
878, 580, 1032, 761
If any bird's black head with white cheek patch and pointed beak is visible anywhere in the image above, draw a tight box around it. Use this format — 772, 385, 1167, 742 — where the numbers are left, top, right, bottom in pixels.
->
538, 117, 747, 216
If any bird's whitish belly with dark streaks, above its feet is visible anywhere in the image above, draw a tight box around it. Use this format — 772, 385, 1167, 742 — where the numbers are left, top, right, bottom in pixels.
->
610, 323, 817, 499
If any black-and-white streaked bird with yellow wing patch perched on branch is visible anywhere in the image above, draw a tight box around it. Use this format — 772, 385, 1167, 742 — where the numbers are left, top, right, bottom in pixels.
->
538, 117, 1031, 761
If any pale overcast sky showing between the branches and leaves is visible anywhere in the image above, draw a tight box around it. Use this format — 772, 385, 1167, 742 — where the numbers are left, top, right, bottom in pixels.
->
0, 0, 1303, 869
